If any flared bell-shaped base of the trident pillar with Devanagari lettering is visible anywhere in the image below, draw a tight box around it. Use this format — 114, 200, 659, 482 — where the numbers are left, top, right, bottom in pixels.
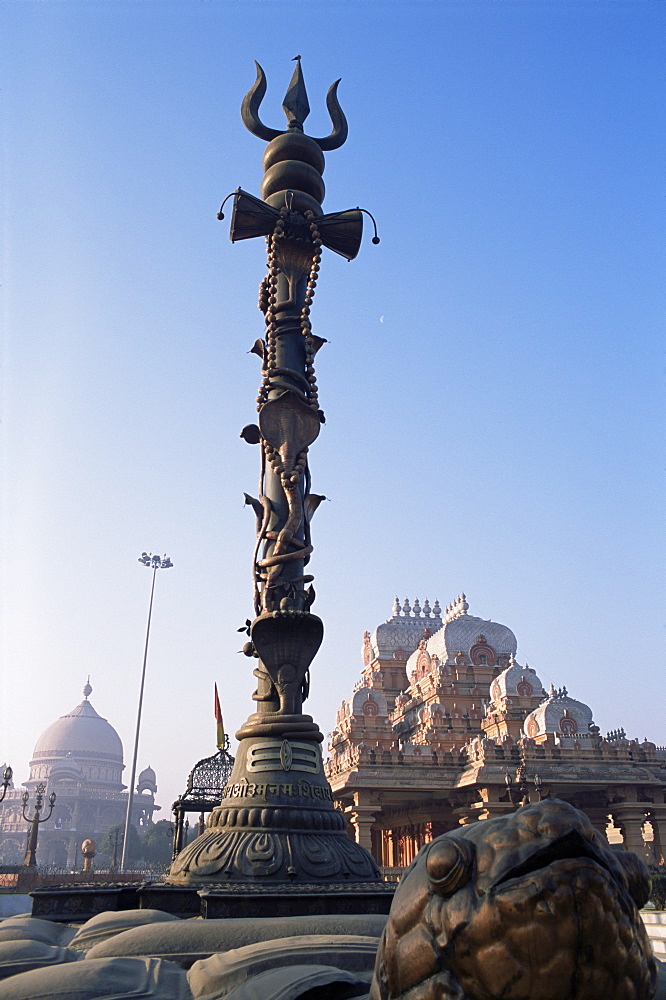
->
167, 713, 381, 891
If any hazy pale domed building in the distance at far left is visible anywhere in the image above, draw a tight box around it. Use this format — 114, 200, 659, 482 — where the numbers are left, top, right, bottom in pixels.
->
0, 681, 160, 869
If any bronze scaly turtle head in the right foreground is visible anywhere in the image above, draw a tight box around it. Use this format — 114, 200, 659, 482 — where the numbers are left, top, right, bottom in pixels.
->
370, 799, 657, 1000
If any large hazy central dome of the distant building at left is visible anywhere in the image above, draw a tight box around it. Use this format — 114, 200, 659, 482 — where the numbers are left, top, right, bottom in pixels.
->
33, 683, 123, 765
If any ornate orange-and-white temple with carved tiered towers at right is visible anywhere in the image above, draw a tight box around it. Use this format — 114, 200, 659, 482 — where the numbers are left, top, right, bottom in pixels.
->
326, 594, 666, 868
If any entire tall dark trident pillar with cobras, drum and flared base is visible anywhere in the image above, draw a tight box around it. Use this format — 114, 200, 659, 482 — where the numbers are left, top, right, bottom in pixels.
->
168, 57, 380, 891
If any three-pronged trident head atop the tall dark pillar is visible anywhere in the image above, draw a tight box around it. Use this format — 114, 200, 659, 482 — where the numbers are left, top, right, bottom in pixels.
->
241, 56, 348, 152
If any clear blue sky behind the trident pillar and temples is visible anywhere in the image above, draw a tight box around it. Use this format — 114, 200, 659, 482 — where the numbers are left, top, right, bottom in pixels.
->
0, 0, 666, 810
